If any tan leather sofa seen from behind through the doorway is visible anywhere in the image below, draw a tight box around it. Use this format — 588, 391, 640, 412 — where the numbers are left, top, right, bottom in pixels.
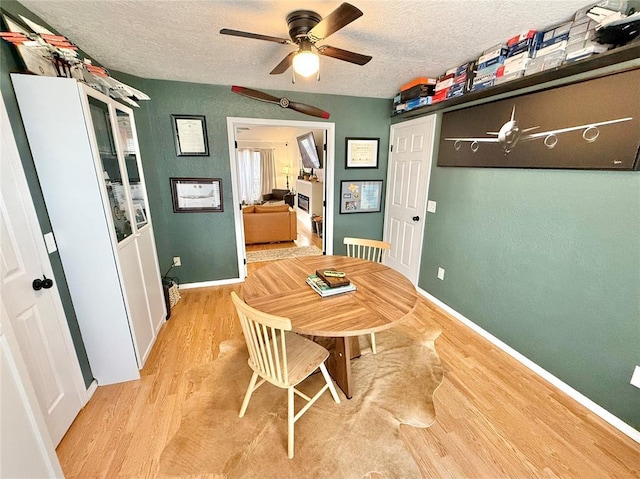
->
242, 205, 298, 244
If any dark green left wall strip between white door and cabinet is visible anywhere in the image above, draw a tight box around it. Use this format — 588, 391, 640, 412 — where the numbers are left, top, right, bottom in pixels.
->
0, 0, 93, 387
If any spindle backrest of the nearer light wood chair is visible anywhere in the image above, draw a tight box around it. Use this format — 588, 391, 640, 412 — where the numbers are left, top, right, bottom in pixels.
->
231, 292, 291, 386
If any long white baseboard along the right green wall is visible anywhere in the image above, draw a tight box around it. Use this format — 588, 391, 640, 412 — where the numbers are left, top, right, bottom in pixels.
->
418, 288, 640, 443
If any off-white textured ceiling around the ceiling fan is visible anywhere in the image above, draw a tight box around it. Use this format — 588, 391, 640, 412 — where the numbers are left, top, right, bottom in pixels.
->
20, 0, 592, 98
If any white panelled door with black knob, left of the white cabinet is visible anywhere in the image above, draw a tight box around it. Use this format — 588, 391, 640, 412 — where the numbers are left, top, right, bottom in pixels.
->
0, 93, 87, 445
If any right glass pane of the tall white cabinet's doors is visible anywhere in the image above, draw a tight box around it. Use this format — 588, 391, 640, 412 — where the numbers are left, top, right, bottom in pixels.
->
116, 108, 149, 229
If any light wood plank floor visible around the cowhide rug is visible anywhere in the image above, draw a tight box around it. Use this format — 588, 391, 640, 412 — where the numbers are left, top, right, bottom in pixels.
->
57, 263, 640, 479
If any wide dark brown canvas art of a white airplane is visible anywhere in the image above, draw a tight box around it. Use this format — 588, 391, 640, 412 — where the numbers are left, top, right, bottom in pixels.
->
438, 70, 640, 170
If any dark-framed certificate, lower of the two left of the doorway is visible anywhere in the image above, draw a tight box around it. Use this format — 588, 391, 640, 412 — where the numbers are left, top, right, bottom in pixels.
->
169, 178, 224, 213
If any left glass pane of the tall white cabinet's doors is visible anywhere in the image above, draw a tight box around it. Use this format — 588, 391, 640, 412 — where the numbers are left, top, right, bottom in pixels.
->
89, 96, 132, 242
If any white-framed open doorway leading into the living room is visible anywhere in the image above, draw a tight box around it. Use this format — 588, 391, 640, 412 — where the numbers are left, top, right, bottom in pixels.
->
227, 118, 335, 277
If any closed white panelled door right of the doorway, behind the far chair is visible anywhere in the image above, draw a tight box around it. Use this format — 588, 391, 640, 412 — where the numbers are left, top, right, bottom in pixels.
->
384, 115, 436, 285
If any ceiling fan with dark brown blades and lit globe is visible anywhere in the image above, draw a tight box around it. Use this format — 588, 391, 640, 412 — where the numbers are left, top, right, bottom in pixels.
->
220, 3, 372, 83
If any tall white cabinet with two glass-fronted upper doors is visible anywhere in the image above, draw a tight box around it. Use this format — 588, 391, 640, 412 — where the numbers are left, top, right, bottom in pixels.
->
11, 74, 166, 385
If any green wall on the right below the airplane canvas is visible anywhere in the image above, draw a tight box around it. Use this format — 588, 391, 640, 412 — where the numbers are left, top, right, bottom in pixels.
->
419, 112, 640, 429
